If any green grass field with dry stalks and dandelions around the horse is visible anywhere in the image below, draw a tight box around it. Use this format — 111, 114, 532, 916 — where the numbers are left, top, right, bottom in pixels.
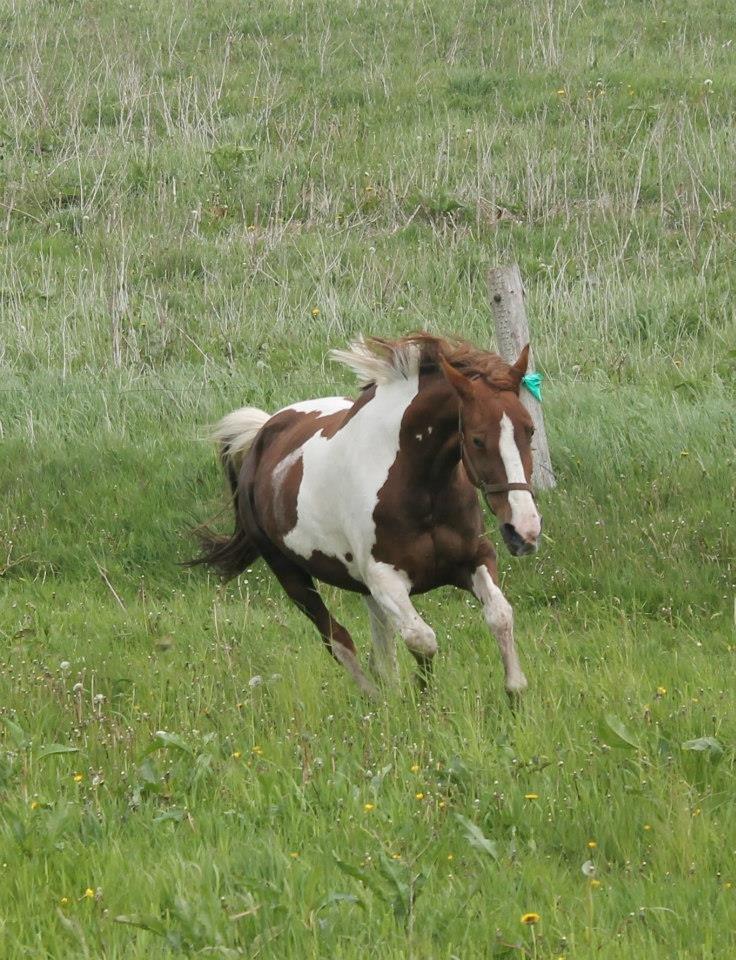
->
0, 0, 736, 960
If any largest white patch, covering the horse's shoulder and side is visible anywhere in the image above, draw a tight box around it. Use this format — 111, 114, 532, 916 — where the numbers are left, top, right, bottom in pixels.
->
277, 350, 419, 583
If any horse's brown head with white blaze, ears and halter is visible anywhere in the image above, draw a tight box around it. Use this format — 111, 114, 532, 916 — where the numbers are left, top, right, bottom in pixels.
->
442, 346, 542, 557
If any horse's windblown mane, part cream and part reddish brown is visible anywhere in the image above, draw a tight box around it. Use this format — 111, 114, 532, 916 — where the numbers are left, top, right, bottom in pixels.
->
330, 333, 517, 390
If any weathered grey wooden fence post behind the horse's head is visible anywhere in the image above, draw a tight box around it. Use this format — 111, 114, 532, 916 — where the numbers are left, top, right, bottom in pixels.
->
488, 264, 556, 490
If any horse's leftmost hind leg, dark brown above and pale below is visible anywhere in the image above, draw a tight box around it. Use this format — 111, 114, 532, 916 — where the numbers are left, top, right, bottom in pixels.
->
264, 551, 378, 697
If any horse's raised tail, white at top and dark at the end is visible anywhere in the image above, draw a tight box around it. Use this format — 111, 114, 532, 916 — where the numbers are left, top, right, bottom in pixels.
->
187, 407, 271, 580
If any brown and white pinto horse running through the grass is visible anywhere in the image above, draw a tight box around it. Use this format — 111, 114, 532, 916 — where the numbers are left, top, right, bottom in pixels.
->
192, 333, 541, 696
